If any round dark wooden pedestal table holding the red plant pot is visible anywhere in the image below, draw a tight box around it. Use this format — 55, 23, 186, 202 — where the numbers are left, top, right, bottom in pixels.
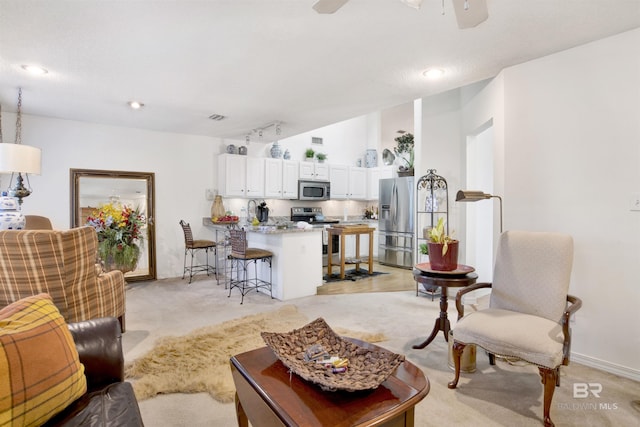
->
413, 262, 478, 349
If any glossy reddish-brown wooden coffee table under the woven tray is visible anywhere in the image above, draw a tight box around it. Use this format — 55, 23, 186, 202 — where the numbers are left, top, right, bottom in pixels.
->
230, 339, 429, 427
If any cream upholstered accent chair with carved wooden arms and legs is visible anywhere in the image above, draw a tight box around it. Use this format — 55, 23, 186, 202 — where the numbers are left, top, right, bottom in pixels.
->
449, 231, 582, 426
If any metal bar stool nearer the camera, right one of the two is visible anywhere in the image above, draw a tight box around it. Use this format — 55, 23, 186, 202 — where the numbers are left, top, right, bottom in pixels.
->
228, 230, 273, 304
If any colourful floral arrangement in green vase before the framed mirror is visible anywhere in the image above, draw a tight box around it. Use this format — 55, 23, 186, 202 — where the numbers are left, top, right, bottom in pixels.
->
87, 202, 146, 272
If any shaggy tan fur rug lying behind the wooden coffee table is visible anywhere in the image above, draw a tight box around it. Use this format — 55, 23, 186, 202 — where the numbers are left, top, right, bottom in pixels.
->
125, 305, 386, 403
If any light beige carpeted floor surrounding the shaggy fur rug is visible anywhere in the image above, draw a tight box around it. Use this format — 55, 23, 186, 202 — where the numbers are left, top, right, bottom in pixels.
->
123, 273, 640, 427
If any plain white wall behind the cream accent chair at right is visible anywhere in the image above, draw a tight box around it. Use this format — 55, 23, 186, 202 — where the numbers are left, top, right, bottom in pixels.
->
430, 30, 640, 379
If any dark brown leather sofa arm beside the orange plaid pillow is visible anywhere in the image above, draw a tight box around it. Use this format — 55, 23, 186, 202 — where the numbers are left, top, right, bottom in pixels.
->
68, 317, 124, 391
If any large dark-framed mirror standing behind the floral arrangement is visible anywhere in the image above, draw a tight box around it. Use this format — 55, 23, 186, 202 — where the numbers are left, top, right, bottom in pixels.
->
70, 169, 156, 282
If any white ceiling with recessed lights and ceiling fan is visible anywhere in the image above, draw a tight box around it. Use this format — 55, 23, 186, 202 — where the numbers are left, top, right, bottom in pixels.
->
0, 0, 640, 140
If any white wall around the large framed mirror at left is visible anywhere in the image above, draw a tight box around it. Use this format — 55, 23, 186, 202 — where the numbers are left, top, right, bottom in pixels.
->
1, 113, 219, 278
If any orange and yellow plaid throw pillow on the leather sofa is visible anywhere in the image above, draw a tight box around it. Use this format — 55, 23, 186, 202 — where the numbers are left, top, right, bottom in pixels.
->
0, 294, 87, 426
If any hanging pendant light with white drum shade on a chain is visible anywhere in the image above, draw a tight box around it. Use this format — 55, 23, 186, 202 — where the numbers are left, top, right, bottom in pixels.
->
0, 88, 41, 206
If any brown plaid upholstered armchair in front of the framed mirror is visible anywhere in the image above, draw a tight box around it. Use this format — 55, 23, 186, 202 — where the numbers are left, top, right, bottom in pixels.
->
0, 227, 125, 331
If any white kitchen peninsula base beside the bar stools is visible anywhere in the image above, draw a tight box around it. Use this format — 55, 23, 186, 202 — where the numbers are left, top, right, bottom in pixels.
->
202, 217, 322, 301
